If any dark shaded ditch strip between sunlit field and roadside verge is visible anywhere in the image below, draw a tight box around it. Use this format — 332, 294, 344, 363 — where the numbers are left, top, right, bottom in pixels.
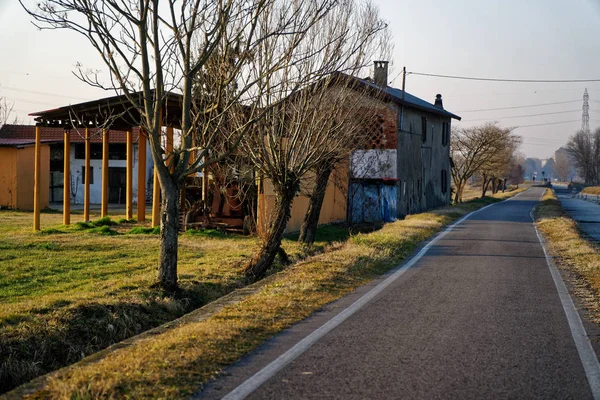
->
0, 281, 238, 394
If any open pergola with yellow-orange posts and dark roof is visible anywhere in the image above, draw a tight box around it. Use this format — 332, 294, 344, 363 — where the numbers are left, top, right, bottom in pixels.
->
29, 92, 183, 231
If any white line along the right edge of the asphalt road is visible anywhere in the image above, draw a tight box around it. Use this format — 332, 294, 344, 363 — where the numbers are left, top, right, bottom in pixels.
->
529, 198, 600, 400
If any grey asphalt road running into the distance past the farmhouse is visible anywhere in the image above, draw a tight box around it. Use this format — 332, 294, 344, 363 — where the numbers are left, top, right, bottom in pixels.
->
198, 188, 593, 399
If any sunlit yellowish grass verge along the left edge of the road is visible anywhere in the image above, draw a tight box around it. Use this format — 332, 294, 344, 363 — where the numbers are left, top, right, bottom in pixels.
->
2, 192, 516, 398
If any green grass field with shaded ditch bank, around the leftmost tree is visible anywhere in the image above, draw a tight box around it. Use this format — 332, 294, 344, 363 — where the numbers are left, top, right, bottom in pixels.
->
0, 210, 347, 393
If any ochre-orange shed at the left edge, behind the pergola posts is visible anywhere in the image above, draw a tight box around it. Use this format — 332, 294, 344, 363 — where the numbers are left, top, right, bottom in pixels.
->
0, 139, 50, 210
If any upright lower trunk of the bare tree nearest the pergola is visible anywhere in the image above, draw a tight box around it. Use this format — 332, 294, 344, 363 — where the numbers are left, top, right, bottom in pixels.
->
158, 182, 180, 292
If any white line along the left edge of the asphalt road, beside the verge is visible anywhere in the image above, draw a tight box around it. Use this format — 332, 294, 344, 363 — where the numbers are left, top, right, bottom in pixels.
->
223, 198, 508, 400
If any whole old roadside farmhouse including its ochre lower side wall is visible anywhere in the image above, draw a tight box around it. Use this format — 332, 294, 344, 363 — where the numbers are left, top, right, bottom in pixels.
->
258, 61, 460, 232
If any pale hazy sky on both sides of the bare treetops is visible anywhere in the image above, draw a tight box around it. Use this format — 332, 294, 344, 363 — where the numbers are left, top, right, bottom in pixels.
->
0, 0, 600, 158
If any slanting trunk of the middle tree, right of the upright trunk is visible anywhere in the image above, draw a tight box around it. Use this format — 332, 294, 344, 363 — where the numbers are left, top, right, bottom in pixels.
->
244, 184, 298, 282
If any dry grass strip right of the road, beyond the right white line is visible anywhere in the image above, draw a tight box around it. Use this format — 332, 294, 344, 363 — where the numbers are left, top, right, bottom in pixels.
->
534, 190, 600, 323
